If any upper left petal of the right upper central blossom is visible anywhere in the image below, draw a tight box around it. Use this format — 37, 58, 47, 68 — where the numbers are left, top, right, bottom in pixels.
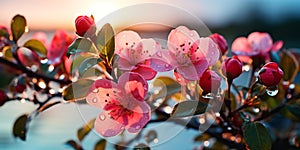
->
168, 26, 200, 53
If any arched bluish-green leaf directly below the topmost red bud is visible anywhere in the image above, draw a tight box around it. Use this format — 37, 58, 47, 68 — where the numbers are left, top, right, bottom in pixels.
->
67, 38, 98, 57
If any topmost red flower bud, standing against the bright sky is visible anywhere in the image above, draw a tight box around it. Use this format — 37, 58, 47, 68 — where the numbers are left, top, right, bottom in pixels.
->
75, 16, 96, 36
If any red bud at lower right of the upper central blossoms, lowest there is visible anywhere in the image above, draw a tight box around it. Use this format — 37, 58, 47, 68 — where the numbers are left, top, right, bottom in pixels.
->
199, 70, 222, 93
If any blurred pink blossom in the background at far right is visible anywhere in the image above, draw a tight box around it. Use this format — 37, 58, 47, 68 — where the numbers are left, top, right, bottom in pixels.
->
232, 32, 283, 62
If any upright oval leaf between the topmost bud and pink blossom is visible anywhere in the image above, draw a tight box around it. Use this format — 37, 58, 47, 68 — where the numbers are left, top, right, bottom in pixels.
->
96, 23, 115, 63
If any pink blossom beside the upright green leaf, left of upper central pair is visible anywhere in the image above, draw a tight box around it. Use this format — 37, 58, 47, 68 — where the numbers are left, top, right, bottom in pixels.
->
115, 31, 160, 80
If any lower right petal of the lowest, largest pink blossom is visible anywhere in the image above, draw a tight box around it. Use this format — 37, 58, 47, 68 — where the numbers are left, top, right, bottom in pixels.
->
125, 101, 151, 133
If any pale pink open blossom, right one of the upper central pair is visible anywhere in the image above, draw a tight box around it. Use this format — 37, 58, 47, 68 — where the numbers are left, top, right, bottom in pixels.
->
151, 26, 220, 80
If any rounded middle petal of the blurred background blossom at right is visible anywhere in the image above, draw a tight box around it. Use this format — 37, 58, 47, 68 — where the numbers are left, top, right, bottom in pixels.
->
248, 32, 273, 53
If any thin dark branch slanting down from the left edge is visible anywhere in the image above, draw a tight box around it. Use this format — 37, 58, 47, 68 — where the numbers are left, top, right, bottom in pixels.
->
0, 57, 71, 85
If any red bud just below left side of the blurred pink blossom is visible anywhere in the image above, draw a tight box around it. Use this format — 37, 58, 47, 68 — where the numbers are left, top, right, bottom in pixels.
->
222, 56, 243, 80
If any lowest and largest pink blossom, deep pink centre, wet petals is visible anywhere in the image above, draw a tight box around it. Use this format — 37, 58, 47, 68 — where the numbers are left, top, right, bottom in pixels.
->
86, 72, 151, 137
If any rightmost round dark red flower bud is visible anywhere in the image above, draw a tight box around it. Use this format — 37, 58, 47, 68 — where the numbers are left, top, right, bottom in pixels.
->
258, 62, 283, 87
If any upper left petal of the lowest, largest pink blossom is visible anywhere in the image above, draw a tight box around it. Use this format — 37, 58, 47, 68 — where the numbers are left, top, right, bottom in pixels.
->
86, 79, 120, 108
